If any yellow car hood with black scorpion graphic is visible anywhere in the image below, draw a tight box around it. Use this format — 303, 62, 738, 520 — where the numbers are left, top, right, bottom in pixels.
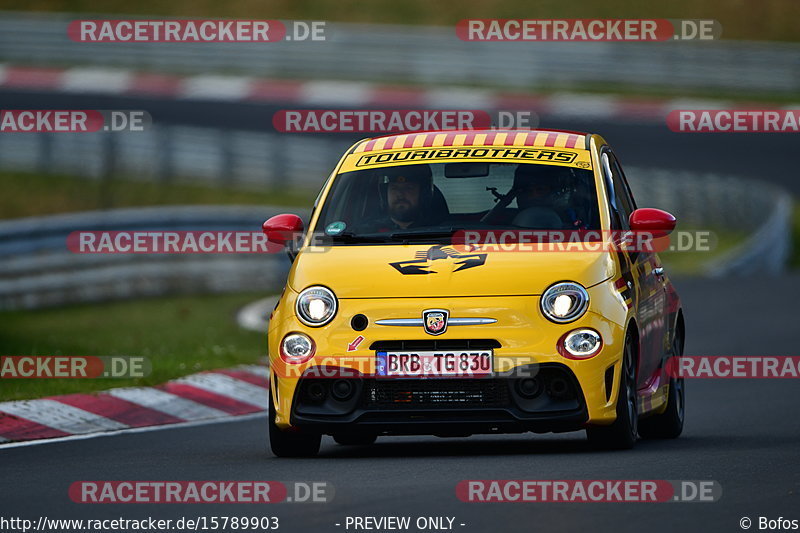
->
289, 245, 614, 298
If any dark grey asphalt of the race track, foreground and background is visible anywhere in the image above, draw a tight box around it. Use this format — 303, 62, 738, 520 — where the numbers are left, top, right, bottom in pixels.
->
0, 88, 800, 532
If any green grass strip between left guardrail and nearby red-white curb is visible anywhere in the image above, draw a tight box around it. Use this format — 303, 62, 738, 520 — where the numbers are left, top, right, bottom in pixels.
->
0, 294, 267, 401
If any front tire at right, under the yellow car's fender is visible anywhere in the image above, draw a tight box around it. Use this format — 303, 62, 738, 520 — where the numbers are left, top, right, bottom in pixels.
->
586, 335, 639, 450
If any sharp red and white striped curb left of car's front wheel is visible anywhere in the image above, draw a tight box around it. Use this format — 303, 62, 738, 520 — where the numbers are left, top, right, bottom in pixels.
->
0, 365, 269, 443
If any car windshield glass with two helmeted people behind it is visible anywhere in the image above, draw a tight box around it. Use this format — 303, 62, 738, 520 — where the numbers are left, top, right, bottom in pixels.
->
316, 162, 600, 243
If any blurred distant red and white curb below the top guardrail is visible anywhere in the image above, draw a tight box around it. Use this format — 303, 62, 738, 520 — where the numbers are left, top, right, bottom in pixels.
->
0, 63, 799, 122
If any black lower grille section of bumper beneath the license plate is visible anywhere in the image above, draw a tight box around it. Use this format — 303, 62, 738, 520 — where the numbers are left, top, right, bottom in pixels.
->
279, 364, 588, 436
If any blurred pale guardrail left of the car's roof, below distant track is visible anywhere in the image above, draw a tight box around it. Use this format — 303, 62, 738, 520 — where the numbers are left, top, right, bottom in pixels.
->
0, 126, 351, 189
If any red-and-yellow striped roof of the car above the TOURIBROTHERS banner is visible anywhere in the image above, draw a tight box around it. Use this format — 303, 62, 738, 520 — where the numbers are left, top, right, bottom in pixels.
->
350, 129, 591, 153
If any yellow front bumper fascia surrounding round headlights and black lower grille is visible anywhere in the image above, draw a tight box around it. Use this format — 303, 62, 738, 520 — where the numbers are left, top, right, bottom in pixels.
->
269, 290, 625, 433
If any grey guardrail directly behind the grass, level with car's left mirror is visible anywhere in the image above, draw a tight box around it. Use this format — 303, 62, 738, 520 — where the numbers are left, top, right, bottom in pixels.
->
0, 206, 307, 310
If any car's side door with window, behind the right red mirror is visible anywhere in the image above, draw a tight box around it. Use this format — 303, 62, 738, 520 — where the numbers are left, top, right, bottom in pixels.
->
601, 148, 666, 388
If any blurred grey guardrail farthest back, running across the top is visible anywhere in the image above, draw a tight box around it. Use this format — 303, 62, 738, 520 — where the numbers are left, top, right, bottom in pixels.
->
0, 12, 800, 93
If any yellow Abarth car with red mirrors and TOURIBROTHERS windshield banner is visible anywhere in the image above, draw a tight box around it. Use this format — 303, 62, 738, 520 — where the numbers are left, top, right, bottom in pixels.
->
263, 130, 685, 457
